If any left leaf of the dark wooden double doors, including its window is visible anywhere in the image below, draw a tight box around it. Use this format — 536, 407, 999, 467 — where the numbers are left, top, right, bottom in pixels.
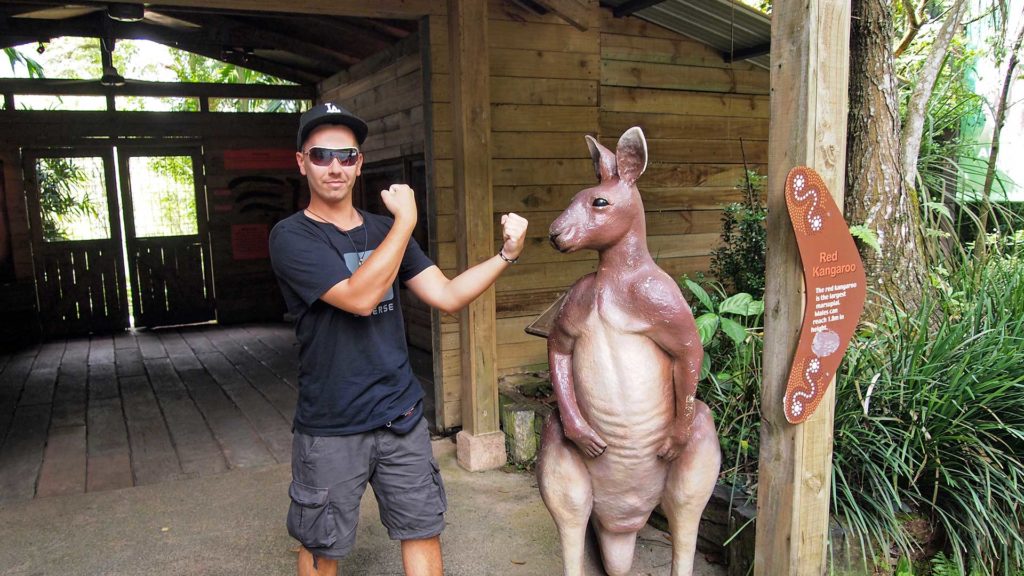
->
23, 147, 129, 337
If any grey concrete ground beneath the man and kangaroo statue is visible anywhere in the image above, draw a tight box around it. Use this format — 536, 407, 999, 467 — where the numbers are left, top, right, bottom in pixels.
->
0, 440, 725, 576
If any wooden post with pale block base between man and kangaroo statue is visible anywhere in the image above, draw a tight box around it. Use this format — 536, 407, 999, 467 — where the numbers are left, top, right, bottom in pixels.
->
447, 0, 505, 470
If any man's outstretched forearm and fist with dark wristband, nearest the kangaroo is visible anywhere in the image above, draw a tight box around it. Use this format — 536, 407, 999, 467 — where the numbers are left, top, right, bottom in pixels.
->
406, 213, 527, 314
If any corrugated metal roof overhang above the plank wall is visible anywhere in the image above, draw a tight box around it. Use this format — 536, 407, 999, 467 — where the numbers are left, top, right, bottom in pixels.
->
601, 0, 771, 69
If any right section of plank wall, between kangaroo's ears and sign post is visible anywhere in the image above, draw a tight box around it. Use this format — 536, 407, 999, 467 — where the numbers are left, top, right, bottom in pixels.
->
600, 10, 769, 277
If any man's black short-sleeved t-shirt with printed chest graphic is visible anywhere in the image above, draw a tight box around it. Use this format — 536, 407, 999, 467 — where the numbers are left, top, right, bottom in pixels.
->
270, 211, 433, 436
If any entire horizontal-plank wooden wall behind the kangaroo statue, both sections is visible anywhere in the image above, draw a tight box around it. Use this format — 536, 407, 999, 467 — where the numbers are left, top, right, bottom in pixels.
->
427, 0, 768, 427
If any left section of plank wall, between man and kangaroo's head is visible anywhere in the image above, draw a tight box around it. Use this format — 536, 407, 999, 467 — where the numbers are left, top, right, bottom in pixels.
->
421, 0, 600, 428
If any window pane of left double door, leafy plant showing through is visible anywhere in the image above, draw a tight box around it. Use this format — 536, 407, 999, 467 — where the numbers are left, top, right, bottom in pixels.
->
36, 157, 111, 242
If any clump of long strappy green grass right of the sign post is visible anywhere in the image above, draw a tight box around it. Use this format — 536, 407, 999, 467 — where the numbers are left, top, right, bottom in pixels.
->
833, 239, 1024, 576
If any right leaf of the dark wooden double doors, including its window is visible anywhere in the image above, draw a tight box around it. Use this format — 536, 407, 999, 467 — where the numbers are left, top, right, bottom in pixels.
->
118, 147, 215, 328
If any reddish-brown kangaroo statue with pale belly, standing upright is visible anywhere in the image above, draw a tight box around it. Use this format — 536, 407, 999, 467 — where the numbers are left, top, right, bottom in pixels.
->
537, 127, 722, 576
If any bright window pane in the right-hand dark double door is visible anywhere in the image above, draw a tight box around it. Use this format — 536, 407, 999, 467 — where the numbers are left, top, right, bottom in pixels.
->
128, 156, 199, 238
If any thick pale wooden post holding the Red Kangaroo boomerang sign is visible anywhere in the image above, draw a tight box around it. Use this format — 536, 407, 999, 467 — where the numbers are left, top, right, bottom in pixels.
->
754, 0, 850, 576
